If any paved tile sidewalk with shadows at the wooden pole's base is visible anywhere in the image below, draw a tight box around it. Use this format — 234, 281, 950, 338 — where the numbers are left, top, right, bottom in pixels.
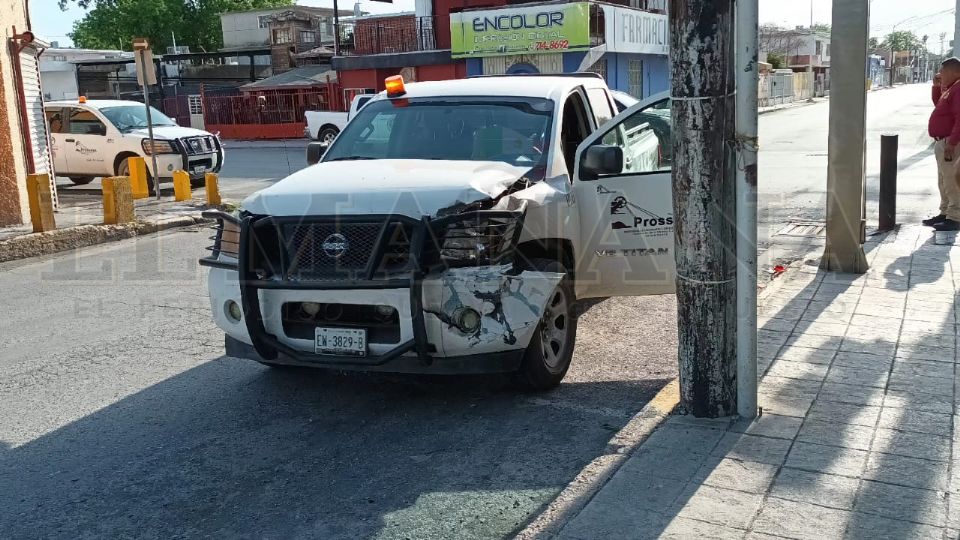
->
556, 226, 960, 540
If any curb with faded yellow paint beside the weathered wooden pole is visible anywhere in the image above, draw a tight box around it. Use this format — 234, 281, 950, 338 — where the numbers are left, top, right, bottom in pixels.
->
515, 379, 680, 540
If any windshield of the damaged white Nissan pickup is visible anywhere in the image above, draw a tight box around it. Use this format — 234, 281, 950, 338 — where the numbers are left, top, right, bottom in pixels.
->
323, 97, 553, 167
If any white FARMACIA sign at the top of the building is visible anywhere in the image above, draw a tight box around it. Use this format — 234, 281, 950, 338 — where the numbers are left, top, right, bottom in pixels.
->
603, 5, 670, 55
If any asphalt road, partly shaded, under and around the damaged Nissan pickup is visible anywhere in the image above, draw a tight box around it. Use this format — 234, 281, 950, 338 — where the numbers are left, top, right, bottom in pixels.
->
0, 230, 676, 539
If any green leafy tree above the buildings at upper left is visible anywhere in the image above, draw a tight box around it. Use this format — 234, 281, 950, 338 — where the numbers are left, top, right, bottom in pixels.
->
59, 0, 294, 52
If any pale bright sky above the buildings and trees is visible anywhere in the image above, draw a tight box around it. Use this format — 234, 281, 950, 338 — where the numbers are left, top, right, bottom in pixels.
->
31, 0, 955, 51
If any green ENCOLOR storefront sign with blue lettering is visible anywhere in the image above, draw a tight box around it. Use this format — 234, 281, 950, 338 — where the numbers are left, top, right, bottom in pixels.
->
450, 2, 590, 58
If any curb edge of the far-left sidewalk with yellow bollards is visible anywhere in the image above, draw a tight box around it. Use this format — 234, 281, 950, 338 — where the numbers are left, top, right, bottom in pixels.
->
0, 216, 208, 263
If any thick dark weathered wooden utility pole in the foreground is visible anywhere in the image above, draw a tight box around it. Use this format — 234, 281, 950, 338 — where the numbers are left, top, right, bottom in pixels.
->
668, 0, 740, 417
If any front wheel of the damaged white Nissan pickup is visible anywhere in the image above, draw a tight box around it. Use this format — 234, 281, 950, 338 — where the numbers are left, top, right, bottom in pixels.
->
517, 259, 577, 390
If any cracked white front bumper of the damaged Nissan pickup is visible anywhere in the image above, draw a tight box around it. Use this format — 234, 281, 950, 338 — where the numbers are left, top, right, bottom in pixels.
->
201, 209, 563, 373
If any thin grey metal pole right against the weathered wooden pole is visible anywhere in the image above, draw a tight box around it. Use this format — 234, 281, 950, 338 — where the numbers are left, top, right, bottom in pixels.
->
736, 0, 756, 418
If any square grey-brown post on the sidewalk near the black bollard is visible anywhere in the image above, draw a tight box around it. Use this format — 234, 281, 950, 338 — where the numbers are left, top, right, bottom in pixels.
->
820, 0, 870, 274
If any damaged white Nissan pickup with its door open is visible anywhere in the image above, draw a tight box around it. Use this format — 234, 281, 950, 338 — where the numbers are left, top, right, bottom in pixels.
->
200, 74, 675, 389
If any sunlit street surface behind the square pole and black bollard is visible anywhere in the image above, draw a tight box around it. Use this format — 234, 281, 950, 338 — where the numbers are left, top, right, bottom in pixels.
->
758, 83, 940, 268
